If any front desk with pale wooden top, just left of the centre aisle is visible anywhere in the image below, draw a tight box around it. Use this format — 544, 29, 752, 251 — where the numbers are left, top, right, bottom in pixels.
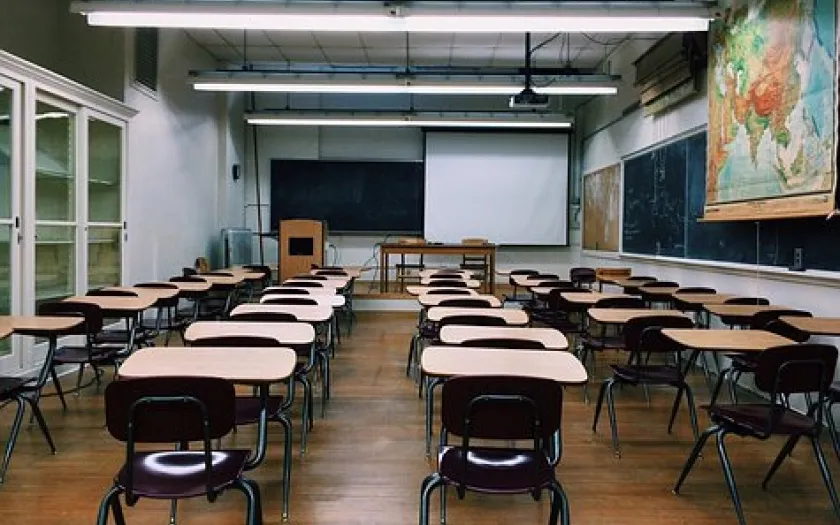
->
119, 346, 297, 520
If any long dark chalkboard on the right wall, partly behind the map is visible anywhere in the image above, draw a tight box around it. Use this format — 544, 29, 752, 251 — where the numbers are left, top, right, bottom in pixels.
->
622, 132, 840, 271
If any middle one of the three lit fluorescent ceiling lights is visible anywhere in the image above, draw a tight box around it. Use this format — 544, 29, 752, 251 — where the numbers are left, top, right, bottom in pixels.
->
192, 79, 618, 96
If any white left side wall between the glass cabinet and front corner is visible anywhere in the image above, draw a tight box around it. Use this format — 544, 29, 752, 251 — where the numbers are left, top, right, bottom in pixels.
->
125, 30, 233, 282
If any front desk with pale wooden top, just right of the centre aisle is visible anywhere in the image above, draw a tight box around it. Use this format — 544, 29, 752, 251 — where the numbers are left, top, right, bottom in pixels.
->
420, 346, 588, 456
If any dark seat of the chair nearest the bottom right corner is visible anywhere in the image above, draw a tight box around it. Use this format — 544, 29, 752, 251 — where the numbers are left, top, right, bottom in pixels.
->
701, 403, 815, 438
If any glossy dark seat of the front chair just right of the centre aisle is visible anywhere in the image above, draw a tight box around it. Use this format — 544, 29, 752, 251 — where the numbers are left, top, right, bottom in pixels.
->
438, 447, 554, 494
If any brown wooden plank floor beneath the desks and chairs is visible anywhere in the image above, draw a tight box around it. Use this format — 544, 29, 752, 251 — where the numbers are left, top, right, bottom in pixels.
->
0, 314, 840, 525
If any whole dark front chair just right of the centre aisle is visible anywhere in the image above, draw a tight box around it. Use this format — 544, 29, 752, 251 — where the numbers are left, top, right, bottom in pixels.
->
420, 376, 570, 525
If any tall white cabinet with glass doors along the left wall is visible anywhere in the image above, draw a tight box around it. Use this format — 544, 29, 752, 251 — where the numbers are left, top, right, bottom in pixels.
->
0, 51, 134, 374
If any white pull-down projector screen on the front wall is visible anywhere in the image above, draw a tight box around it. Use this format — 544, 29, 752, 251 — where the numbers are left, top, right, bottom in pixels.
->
424, 131, 569, 246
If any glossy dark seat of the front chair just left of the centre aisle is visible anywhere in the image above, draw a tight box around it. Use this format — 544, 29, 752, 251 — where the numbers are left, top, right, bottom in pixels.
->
115, 450, 249, 499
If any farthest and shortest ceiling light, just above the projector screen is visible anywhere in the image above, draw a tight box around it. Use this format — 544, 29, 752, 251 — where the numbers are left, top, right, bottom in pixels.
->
245, 111, 572, 129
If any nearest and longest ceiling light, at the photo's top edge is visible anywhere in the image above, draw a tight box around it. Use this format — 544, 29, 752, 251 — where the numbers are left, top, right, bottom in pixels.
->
71, 0, 713, 33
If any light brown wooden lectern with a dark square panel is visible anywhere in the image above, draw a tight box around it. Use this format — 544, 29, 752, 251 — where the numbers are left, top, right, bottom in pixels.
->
278, 219, 327, 282
